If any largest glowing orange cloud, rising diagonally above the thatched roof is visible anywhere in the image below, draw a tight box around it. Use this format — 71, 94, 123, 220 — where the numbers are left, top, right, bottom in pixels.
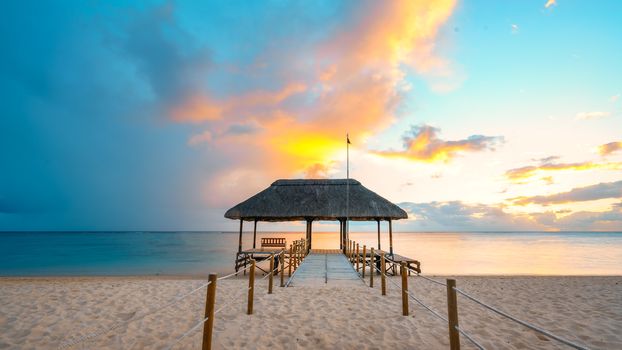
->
171, 0, 464, 202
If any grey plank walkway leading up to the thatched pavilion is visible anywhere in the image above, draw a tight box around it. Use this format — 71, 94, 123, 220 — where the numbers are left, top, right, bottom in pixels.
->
287, 250, 364, 287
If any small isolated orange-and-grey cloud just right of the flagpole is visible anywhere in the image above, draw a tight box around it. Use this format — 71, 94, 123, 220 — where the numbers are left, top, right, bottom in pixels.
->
375, 125, 503, 162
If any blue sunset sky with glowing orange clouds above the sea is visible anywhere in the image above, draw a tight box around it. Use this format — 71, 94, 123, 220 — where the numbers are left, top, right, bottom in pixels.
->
0, 0, 622, 231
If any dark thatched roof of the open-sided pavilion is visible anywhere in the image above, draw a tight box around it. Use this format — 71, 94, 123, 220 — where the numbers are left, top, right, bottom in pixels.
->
225, 179, 408, 221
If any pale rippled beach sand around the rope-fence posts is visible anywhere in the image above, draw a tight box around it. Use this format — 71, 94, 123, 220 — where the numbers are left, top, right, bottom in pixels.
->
0, 277, 622, 349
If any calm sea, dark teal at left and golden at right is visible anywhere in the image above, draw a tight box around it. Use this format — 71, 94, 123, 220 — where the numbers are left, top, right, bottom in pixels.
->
0, 232, 622, 276
